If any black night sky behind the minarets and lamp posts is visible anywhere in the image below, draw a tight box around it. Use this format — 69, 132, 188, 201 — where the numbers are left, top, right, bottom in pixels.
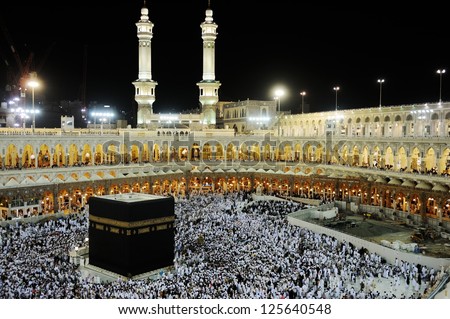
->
0, 0, 450, 119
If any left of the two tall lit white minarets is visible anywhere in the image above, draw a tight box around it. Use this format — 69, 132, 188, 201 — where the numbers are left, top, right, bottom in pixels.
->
133, 0, 158, 127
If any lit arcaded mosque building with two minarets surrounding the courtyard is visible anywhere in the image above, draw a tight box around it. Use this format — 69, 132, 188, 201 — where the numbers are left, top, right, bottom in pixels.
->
0, 3, 450, 240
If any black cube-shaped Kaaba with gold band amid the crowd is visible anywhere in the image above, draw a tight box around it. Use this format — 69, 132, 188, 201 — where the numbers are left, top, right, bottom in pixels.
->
89, 193, 175, 278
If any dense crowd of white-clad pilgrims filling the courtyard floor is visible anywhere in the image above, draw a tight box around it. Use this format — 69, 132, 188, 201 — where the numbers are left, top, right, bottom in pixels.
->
0, 192, 437, 299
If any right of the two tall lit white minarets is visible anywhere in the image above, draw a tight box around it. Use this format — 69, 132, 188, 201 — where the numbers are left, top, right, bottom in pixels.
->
197, 0, 220, 126
